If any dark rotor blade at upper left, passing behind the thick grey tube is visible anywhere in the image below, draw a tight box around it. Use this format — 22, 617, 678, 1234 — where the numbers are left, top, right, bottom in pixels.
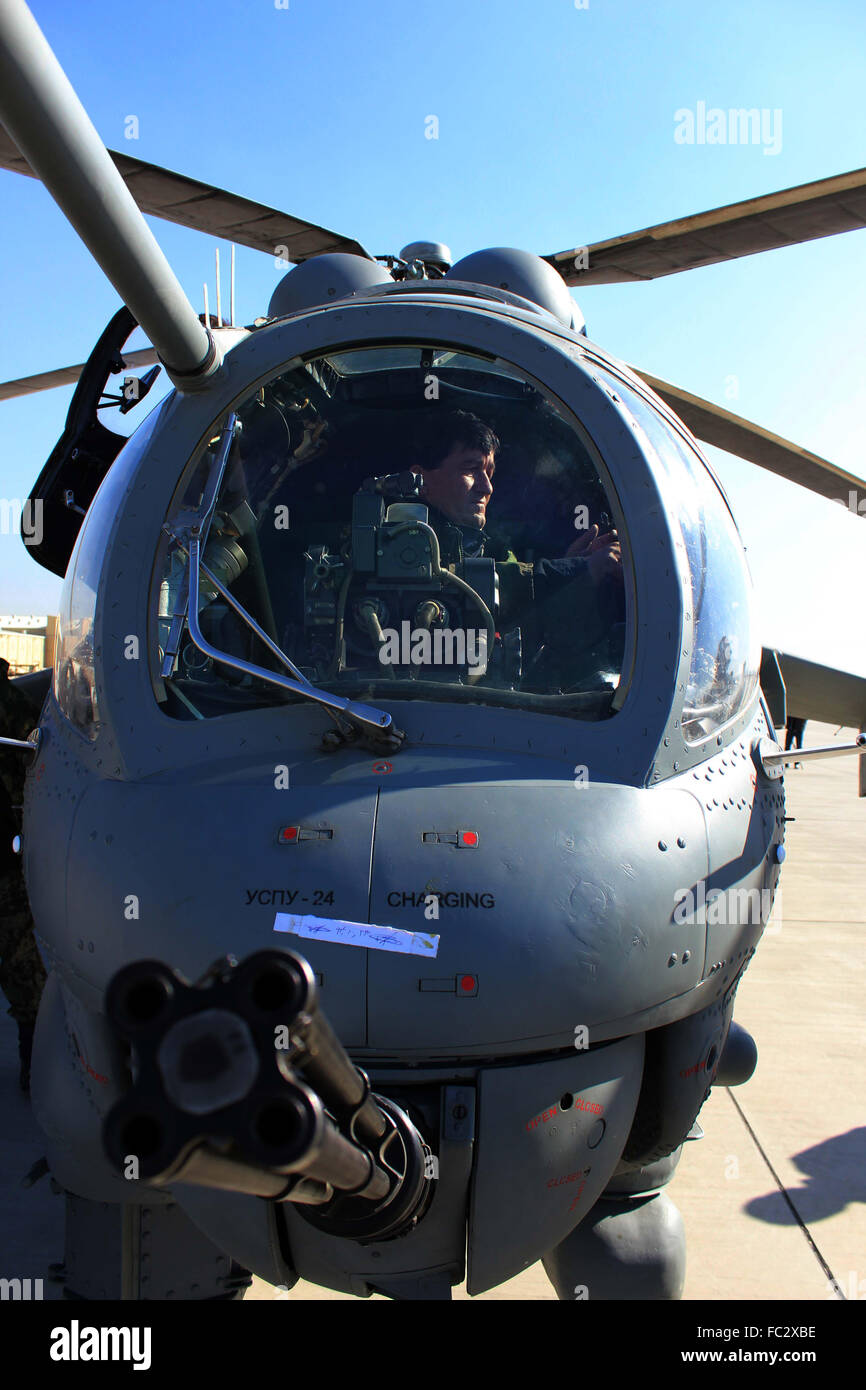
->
0, 126, 371, 261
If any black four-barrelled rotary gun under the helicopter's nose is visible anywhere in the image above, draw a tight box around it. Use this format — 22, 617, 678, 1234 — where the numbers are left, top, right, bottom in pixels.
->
103, 951, 435, 1241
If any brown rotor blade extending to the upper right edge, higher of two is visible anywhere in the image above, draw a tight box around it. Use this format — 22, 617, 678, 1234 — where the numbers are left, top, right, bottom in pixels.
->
544, 170, 866, 285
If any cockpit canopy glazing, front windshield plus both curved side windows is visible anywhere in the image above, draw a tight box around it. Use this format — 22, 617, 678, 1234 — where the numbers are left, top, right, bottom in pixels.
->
54, 339, 760, 770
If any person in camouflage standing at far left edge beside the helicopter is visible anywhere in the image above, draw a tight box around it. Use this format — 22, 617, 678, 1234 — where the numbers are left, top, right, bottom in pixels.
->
0, 657, 46, 1091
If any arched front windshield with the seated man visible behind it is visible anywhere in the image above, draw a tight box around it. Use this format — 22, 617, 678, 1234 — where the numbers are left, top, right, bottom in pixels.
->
153, 345, 630, 720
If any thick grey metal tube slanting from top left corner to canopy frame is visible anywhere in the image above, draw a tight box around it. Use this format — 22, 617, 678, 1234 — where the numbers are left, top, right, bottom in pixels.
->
0, 0, 220, 391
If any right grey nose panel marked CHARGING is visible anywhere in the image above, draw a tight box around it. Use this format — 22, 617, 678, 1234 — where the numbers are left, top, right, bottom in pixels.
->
368, 781, 708, 1056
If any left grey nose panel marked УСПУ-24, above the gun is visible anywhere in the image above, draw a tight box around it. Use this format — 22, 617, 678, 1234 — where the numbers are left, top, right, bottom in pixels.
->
68, 783, 386, 1048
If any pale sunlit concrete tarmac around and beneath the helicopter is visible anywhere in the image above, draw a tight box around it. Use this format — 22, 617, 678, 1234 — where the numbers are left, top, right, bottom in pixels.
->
0, 723, 866, 1302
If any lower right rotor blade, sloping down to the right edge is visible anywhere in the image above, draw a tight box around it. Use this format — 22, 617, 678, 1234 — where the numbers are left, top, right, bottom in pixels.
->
631, 367, 866, 516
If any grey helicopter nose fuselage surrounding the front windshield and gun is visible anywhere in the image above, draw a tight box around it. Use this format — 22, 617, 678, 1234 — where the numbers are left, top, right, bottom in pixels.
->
24, 286, 784, 1293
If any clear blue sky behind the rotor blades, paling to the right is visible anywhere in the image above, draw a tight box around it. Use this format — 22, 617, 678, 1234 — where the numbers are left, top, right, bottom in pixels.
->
0, 0, 866, 674
